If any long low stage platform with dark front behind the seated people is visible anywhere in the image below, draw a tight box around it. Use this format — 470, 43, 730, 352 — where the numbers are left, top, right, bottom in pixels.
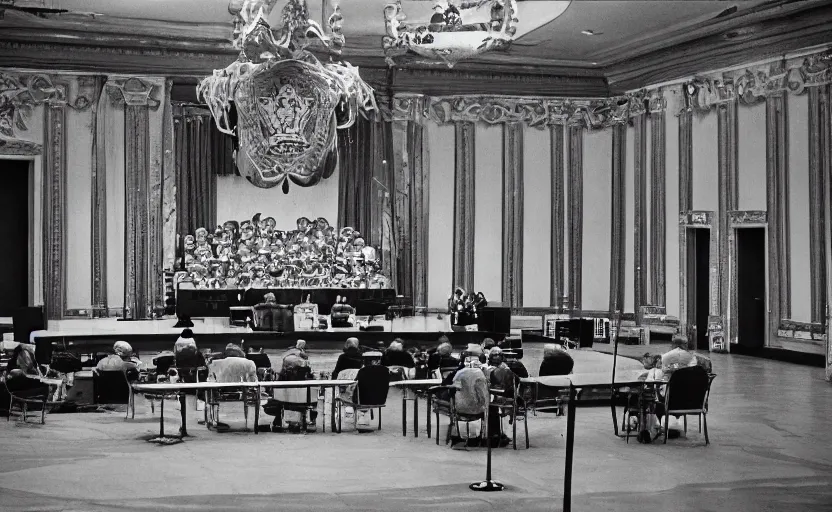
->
32, 316, 506, 361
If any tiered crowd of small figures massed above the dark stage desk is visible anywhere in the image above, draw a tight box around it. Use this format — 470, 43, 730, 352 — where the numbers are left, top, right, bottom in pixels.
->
179, 213, 387, 289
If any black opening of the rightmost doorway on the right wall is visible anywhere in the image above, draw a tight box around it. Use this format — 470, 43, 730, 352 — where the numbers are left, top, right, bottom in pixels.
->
736, 228, 766, 349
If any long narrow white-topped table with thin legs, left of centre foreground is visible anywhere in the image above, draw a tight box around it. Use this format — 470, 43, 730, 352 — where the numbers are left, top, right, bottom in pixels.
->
131, 379, 355, 438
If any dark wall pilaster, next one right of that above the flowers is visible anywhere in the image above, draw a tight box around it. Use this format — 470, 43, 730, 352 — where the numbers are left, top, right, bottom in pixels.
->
503, 123, 523, 309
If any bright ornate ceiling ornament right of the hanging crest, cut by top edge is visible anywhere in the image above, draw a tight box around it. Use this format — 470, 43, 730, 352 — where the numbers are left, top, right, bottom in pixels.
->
382, 0, 518, 67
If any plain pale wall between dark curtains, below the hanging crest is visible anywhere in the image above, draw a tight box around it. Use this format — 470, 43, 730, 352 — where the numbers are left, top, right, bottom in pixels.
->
217, 174, 342, 232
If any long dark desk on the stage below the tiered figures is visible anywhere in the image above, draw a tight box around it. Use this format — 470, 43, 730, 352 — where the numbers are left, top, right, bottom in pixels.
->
176, 287, 396, 318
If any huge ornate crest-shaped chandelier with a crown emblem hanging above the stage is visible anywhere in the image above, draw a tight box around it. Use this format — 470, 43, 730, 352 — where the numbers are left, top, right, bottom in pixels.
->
197, 0, 377, 192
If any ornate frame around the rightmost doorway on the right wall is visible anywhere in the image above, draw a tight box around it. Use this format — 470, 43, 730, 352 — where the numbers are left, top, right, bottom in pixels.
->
726, 210, 772, 353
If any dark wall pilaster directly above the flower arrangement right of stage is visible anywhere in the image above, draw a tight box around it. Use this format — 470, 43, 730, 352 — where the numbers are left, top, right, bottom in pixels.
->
453, 122, 476, 293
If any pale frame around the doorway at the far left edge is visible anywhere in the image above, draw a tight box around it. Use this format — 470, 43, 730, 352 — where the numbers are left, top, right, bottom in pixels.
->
0, 154, 43, 306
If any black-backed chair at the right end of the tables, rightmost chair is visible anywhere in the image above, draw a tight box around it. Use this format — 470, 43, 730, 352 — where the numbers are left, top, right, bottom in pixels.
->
664, 366, 716, 445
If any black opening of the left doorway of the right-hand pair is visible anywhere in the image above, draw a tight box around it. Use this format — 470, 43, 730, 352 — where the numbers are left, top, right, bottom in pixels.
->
687, 228, 711, 350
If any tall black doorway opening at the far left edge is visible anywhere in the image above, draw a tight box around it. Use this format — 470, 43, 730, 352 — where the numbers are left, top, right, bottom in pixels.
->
0, 160, 29, 317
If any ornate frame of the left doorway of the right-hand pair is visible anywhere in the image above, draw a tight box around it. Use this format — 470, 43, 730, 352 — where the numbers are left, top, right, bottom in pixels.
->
679, 210, 720, 349
